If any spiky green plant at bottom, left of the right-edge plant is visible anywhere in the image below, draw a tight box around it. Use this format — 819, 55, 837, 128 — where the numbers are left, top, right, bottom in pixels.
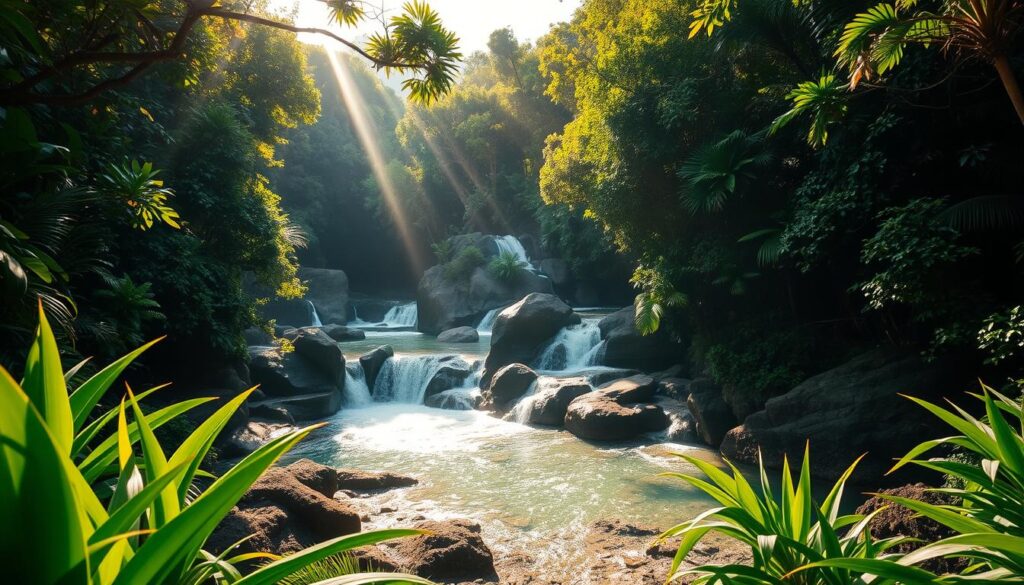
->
659, 449, 917, 585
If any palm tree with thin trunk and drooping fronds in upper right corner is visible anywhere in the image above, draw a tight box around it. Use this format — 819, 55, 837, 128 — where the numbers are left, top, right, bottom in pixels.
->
836, 0, 1024, 124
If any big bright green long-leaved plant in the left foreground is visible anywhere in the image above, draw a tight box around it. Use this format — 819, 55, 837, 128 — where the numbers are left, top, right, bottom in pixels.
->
0, 305, 428, 585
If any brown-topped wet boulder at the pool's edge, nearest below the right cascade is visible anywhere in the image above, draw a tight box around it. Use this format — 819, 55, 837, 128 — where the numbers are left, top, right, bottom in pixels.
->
564, 376, 669, 441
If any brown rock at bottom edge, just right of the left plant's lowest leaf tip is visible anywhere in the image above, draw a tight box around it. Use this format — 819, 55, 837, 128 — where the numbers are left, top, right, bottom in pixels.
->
393, 519, 498, 583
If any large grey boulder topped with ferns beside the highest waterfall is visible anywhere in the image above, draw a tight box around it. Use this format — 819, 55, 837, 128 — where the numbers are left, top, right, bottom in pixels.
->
416, 234, 554, 335
